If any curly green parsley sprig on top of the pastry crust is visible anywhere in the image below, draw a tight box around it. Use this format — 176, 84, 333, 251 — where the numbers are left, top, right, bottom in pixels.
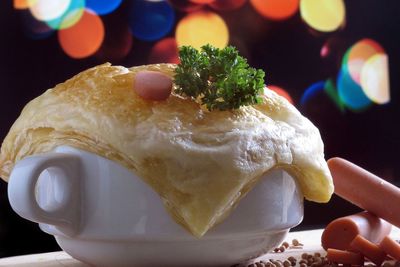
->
174, 45, 265, 111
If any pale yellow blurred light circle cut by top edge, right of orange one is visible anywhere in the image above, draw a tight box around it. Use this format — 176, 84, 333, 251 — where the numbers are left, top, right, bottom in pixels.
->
300, 0, 346, 32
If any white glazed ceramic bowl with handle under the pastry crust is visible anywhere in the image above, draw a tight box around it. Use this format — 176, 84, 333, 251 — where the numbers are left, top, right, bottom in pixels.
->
8, 146, 303, 267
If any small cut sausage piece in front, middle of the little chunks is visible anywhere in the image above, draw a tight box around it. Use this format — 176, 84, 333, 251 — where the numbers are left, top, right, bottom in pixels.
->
350, 235, 386, 266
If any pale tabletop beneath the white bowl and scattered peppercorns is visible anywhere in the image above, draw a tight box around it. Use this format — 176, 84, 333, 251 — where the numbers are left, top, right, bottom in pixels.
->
0, 227, 400, 267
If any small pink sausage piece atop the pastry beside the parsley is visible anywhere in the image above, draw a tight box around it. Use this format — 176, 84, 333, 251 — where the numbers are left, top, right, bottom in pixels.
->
133, 70, 172, 101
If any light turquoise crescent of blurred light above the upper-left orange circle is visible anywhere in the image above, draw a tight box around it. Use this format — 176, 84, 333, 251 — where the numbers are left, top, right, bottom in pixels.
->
46, 0, 85, 30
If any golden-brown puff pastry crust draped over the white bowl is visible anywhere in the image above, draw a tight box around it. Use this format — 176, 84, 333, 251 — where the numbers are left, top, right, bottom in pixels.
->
0, 64, 333, 237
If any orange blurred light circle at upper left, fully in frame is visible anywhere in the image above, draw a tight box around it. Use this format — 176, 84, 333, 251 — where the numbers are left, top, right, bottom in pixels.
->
58, 10, 104, 59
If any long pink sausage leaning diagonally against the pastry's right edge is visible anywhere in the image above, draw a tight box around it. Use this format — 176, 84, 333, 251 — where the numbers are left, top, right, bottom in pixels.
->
328, 158, 400, 227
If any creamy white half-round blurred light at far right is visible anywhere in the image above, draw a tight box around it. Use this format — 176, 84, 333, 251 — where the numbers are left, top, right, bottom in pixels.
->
361, 53, 390, 104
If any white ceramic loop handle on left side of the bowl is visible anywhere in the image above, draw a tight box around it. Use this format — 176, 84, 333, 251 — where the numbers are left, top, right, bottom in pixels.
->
8, 153, 81, 236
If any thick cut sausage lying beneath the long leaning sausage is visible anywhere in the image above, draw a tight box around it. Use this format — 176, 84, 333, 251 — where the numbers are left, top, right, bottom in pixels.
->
321, 211, 392, 250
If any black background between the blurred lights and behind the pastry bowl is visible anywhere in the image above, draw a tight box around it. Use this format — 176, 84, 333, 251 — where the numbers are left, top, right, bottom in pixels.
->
0, 0, 400, 257
